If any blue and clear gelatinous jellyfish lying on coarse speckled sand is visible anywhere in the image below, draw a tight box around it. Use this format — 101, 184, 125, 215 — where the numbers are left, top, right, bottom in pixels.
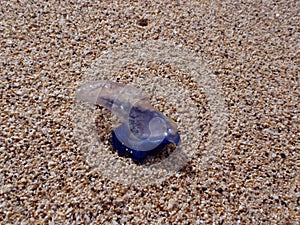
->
76, 80, 180, 163
